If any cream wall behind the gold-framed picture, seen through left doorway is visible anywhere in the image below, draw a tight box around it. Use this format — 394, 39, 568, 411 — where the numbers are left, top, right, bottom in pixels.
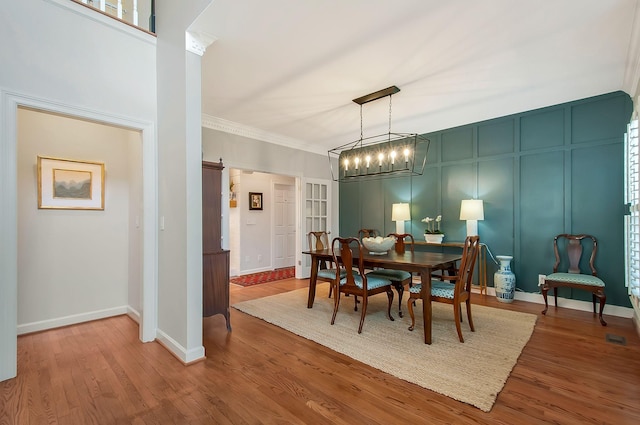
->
18, 108, 141, 333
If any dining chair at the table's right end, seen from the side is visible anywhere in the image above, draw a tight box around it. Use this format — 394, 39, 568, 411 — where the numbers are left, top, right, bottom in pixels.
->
407, 236, 480, 342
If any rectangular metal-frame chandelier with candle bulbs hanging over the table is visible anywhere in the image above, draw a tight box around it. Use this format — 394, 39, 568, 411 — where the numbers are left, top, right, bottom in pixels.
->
328, 86, 430, 181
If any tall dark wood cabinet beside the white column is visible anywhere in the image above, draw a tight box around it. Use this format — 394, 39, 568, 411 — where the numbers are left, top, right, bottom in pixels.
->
202, 159, 231, 330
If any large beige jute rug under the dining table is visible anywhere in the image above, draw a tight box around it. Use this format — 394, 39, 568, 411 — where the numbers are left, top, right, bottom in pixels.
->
233, 283, 536, 412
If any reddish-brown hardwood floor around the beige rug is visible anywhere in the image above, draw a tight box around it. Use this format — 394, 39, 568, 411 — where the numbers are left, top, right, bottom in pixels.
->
0, 279, 640, 425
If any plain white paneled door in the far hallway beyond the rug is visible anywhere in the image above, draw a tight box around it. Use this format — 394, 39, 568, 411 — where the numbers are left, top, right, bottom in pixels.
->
273, 184, 296, 269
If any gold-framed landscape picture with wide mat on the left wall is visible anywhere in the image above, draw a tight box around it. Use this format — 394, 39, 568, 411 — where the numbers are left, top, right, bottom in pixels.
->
38, 155, 104, 210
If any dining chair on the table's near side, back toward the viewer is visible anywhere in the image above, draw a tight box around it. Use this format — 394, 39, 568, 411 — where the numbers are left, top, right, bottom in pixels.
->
331, 237, 394, 333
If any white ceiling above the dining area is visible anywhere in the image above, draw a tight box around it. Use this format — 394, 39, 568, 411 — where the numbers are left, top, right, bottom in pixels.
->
189, 0, 640, 154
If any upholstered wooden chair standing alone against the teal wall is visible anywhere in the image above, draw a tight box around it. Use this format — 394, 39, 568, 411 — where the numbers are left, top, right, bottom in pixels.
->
540, 233, 607, 326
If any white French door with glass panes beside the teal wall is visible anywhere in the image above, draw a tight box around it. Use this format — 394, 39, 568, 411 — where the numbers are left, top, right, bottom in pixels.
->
300, 179, 331, 278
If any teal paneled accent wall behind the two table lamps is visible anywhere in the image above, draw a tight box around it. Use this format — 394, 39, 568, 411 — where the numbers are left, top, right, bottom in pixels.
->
339, 92, 633, 307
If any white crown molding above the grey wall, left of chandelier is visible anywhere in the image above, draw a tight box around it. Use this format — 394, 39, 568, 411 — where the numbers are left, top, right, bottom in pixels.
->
202, 114, 327, 155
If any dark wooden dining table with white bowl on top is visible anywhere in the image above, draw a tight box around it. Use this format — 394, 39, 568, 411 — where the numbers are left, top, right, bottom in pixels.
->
303, 249, 462, 344
